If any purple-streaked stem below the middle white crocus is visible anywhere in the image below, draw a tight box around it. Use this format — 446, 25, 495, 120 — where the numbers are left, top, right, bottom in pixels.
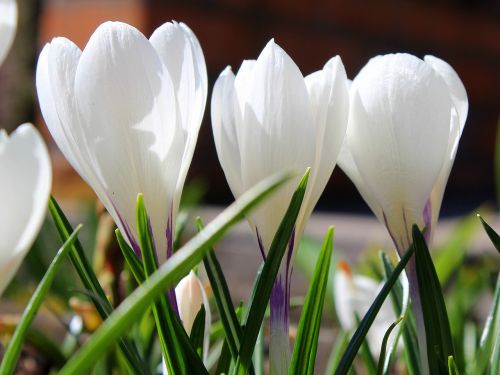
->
269, 266, 290, 375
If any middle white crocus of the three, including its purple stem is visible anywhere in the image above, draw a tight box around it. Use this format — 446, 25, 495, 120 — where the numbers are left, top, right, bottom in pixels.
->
212, 40, 349, 373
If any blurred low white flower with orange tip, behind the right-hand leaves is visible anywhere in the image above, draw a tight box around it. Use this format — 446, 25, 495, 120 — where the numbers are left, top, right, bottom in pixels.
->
333, 261, 408, 358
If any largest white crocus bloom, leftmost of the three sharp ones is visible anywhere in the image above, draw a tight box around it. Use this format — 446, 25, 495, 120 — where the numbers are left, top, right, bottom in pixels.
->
36, 22, 207, 262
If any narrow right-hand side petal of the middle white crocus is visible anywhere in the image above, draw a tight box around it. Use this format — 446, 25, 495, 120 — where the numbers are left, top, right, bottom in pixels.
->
305, 56, 349, 223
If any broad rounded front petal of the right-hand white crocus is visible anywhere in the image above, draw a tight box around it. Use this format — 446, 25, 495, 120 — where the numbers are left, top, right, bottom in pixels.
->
347, 54, 453, 247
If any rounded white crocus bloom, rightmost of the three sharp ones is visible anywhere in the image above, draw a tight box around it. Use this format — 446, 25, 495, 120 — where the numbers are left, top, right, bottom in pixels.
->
338, 54, 468, 252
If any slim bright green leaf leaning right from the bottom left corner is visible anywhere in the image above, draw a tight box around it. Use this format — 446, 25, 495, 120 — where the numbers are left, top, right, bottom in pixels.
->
0, 225, 82, 375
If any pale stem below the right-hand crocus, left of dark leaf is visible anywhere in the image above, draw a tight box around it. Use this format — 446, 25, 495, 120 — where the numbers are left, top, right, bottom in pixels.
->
406, 256, 429, 375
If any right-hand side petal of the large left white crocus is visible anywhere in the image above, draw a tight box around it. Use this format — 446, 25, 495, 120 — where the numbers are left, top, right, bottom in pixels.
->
150, 22, 207, 203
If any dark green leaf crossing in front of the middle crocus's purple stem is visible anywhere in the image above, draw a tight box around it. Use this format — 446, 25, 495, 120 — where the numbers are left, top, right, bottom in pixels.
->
235, 168, 310, 375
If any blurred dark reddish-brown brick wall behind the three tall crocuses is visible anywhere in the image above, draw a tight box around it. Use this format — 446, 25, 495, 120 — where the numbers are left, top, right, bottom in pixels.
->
41, 0, 500, 211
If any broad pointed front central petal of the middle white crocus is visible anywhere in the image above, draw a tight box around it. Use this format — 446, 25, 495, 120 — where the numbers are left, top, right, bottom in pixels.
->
236, 40, 316, 247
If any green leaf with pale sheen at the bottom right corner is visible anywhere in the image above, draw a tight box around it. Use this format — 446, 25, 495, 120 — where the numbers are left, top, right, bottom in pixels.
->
472, 274, 500, 375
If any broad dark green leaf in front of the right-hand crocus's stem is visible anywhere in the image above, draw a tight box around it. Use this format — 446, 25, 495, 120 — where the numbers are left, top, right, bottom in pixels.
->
412, 225, 454, 374
